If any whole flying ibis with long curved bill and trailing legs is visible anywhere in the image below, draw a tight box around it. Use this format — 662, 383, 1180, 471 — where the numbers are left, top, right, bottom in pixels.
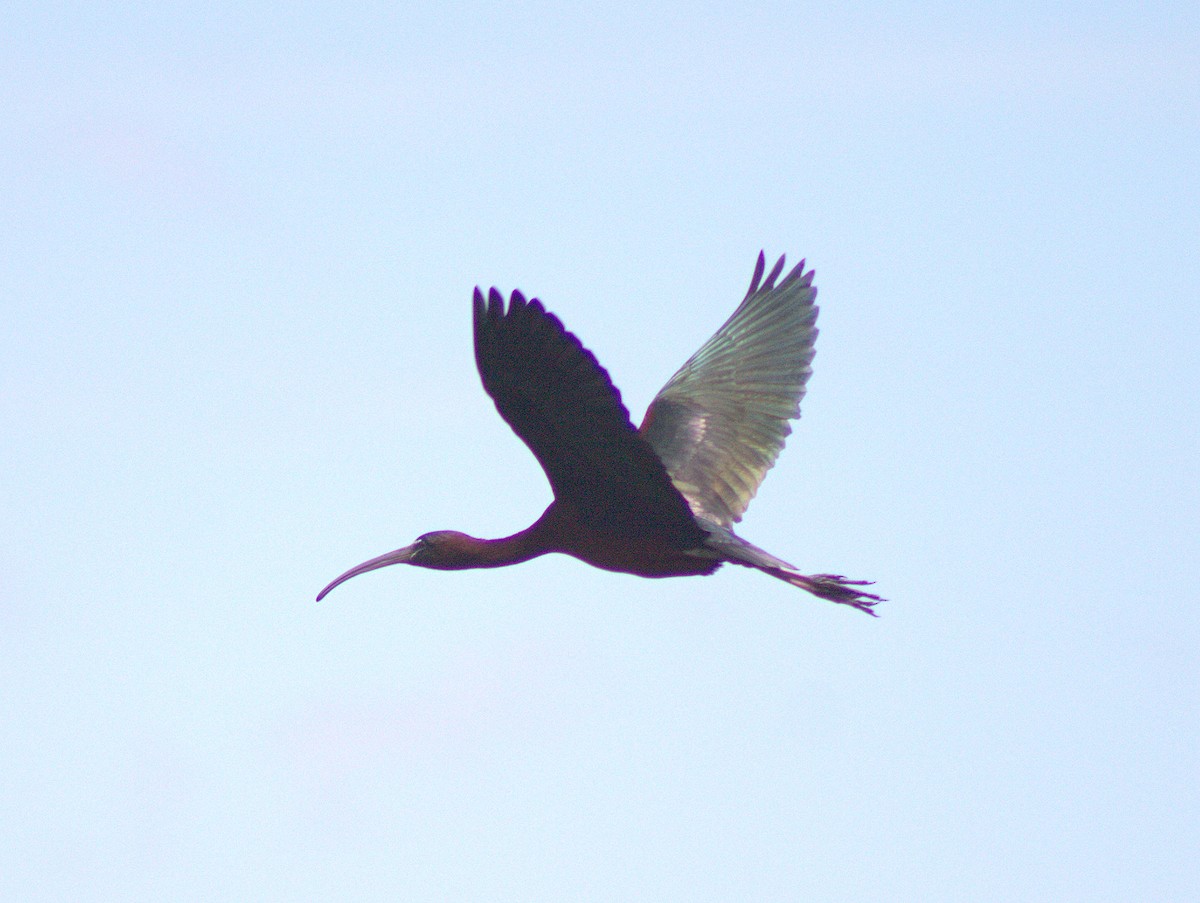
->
317, 253, 883, 615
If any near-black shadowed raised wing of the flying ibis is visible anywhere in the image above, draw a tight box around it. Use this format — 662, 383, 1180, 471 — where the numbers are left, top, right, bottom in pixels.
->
475, 288, 706, 549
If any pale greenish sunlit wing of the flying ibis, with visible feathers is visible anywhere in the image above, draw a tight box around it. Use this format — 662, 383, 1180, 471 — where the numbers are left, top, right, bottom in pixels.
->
641, 253, 817, 527
